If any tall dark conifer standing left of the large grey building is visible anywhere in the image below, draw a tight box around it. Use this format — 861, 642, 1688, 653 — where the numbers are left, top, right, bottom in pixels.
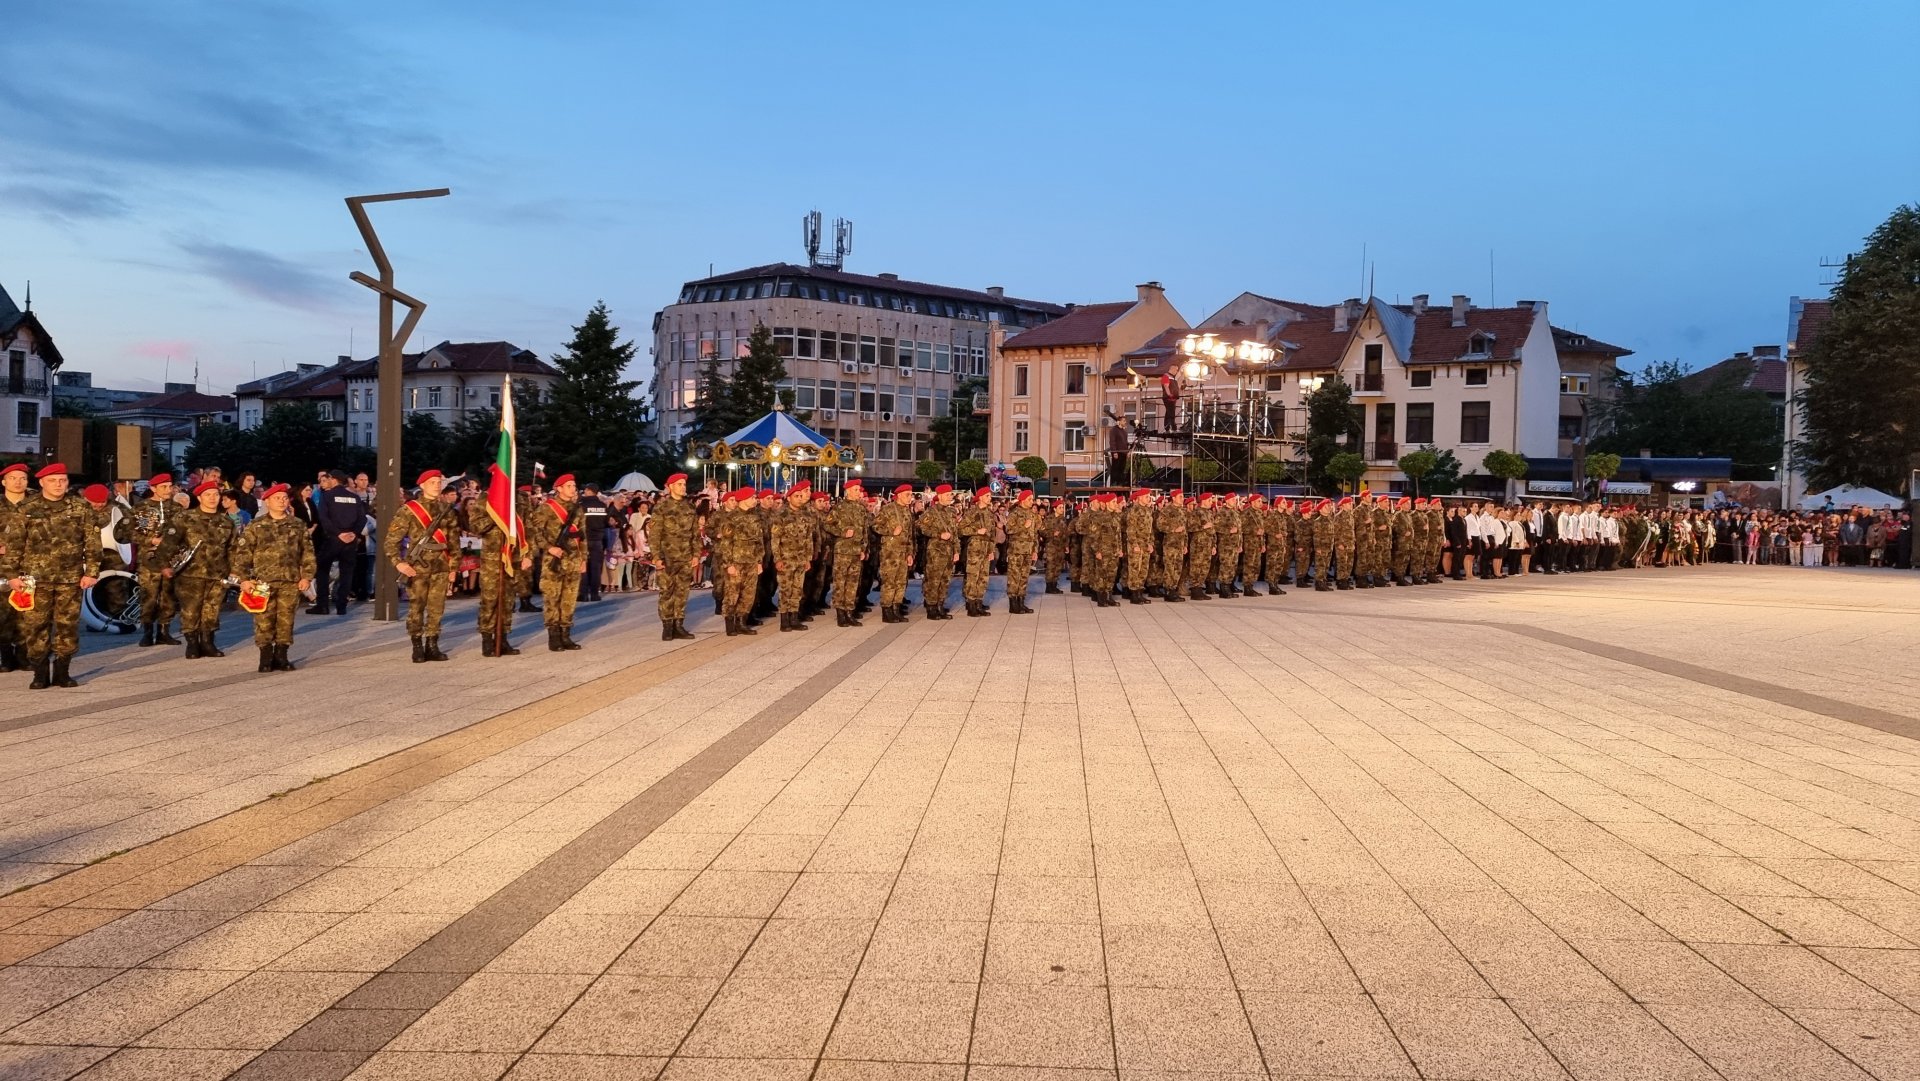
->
537, 301, 647, 484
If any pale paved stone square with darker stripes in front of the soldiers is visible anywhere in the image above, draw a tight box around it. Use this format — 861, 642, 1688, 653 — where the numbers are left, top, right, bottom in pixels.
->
0, 566, 1920, 1081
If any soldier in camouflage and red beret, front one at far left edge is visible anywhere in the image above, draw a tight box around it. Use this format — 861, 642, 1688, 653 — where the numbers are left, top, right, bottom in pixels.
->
0, 463, 100, 691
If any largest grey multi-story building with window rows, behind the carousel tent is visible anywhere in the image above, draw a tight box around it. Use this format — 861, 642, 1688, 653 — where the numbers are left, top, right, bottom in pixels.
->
649, 263, 1068, 476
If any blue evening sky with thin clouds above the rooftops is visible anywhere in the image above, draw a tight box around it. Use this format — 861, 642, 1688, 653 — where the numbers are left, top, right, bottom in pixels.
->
0, 0, 1920, 392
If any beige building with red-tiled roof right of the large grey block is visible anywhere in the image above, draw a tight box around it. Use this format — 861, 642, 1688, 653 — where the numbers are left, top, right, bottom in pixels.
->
987, 282, 1187, 482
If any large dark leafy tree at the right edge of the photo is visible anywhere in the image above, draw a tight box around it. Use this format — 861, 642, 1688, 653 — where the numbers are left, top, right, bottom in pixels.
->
1795, 204, 1920, 492
